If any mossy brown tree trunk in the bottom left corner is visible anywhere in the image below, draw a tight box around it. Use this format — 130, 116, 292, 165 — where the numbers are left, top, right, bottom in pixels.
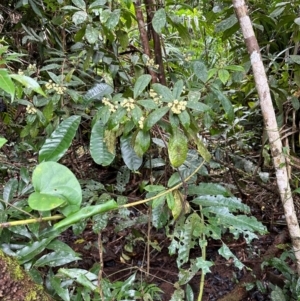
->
0, 250, 54, 301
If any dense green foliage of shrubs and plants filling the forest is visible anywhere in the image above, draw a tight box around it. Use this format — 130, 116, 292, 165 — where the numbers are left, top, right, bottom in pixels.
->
0, 0, 300, 301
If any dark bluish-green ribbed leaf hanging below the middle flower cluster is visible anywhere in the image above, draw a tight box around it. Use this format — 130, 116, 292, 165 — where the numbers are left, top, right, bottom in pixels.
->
120, 135, 143, 170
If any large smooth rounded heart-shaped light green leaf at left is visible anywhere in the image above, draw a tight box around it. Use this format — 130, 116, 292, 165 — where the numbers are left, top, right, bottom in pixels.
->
28, 161, 82, 216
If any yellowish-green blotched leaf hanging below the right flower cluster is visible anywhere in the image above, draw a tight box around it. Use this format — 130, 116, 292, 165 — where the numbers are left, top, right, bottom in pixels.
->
168, 129, 188, 167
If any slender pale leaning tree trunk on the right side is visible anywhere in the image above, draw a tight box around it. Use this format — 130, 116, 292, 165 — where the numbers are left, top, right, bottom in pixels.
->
232, 0, 300, 275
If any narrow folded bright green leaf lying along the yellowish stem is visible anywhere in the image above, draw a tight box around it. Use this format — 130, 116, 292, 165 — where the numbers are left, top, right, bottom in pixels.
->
54, 200, 118, 229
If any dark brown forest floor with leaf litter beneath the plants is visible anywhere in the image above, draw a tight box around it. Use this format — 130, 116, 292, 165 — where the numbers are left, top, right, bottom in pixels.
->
0, 139, 298, 301
